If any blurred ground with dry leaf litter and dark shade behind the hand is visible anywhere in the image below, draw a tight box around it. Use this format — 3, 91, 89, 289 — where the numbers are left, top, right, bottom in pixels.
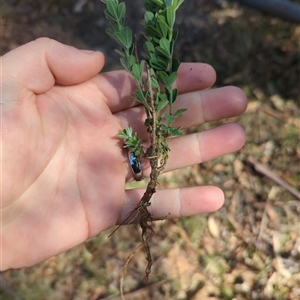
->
0, 0, 300, 300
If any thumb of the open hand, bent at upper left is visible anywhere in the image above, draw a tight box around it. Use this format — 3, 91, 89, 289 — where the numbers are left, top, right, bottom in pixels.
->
1, 38, 105, 102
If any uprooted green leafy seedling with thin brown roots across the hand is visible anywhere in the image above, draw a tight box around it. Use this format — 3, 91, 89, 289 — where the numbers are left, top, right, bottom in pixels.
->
102, 0, 186, 296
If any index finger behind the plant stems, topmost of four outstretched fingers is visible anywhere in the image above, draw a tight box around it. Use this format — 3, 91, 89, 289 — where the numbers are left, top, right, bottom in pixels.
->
93, 63, 216, 113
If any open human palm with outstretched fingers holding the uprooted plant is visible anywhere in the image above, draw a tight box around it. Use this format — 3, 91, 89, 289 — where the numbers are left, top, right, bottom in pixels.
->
0, 38, 247, 270
